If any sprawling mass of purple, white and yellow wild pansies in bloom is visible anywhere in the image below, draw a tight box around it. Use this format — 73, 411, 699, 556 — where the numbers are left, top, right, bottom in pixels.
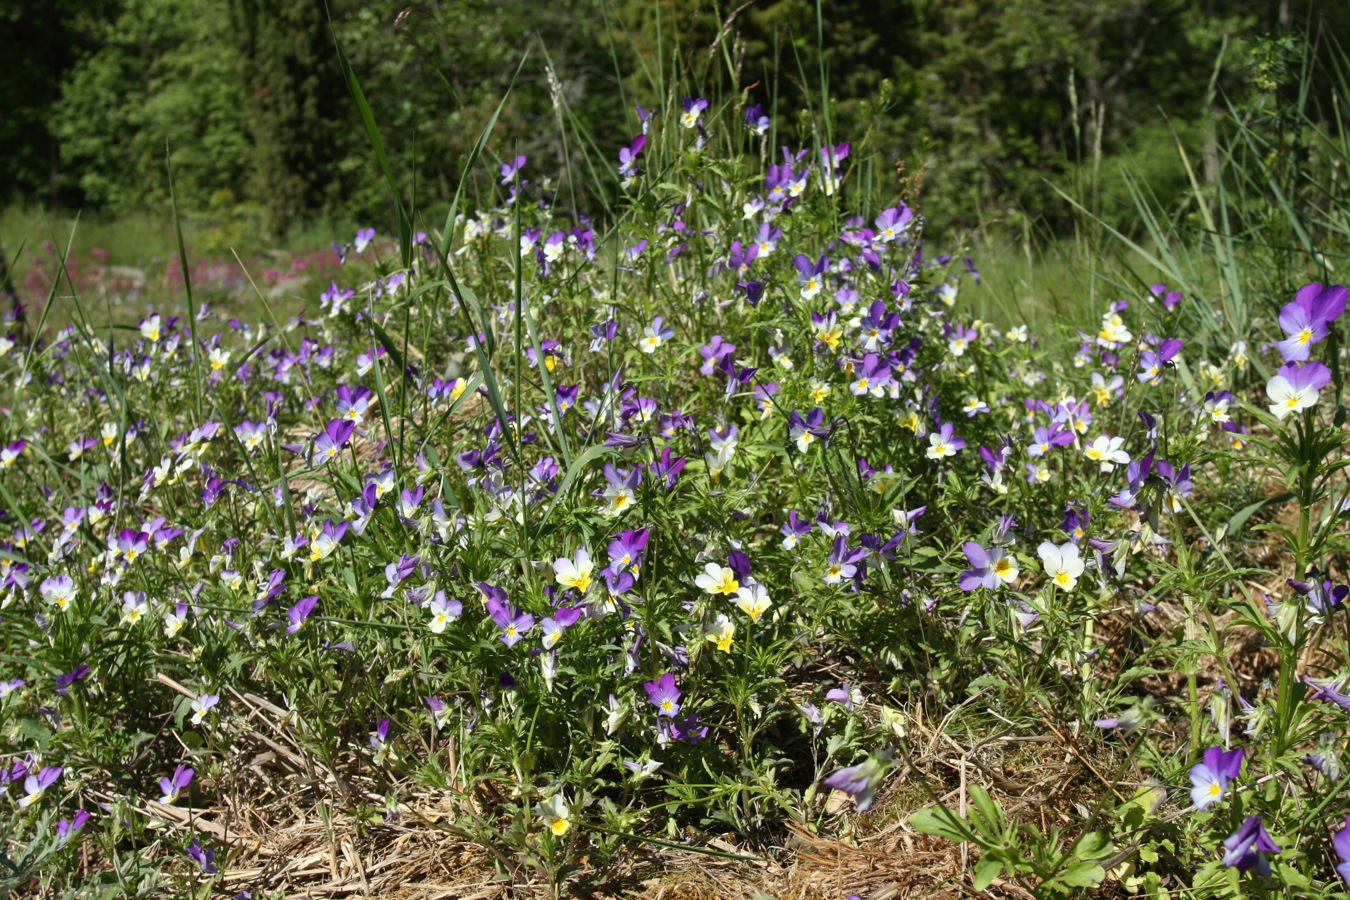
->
0, 89, 1350, 872
